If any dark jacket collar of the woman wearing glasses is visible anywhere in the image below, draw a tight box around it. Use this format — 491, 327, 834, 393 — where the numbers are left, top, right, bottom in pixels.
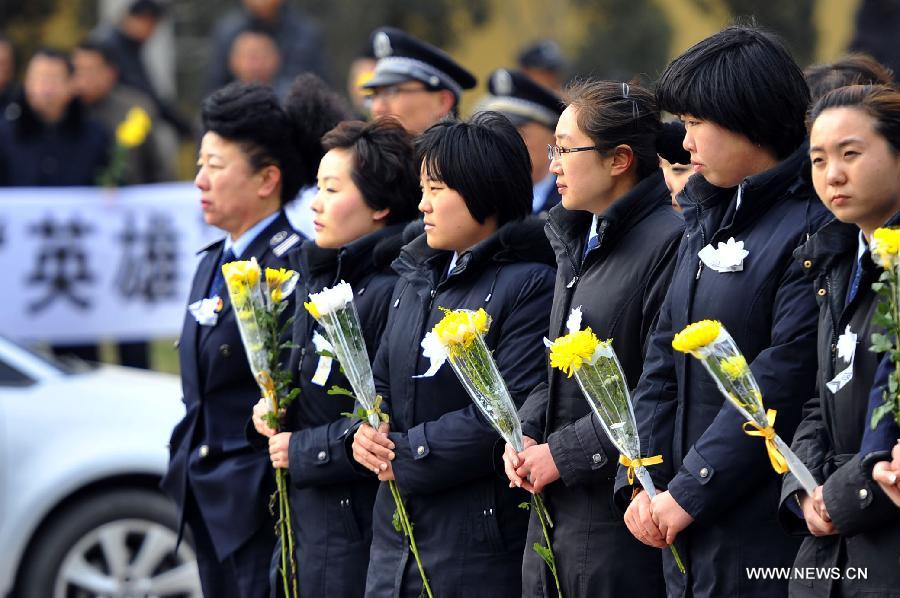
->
547, 171, 671, 255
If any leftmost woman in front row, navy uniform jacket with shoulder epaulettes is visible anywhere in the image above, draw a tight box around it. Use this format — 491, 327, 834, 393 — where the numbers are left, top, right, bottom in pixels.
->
162, 84, 301, 598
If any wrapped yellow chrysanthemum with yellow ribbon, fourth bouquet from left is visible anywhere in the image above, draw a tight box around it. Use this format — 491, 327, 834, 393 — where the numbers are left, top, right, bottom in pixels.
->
544, 306, 685, 573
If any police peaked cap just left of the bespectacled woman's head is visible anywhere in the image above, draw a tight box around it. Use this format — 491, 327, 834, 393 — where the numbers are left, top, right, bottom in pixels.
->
478, 69, 565, 129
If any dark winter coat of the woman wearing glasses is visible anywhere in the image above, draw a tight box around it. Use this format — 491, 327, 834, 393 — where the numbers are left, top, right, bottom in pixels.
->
519, 172, 684, 598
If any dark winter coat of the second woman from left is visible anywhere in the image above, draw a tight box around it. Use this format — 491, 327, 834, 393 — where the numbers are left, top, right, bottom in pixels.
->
276, 225, 403, 598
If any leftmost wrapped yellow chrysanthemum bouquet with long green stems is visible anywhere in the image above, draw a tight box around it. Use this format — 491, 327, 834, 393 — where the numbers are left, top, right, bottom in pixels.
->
222, 258, 300, 598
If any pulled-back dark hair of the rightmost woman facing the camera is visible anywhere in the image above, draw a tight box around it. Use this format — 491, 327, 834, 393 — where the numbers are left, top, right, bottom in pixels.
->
806, 85, 900, 154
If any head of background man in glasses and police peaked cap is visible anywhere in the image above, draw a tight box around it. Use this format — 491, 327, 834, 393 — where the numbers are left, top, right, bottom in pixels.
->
363, 27, 478, 135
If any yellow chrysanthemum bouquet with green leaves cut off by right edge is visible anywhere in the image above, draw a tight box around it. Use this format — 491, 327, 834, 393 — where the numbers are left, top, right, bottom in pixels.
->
870, 228, 900, 430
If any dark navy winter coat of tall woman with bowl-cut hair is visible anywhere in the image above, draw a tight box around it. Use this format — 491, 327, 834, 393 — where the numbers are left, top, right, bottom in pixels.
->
616, 147, 828, 598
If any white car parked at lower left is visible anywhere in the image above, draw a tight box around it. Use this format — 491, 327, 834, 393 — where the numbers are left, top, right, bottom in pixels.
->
0, 337, 201, 598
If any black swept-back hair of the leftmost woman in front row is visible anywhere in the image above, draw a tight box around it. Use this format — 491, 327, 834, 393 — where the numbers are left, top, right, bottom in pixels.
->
201, 82, 301, 205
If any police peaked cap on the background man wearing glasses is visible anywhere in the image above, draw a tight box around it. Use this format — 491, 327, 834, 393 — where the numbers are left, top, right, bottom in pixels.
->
363, 27, 478, 100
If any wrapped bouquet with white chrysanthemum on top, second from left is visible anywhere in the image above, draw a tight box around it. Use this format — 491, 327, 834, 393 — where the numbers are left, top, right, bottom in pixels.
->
303, 280, 433, 598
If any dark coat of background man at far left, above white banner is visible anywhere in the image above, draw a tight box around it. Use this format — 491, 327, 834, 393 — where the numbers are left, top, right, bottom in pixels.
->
0, 95, 112, 187
